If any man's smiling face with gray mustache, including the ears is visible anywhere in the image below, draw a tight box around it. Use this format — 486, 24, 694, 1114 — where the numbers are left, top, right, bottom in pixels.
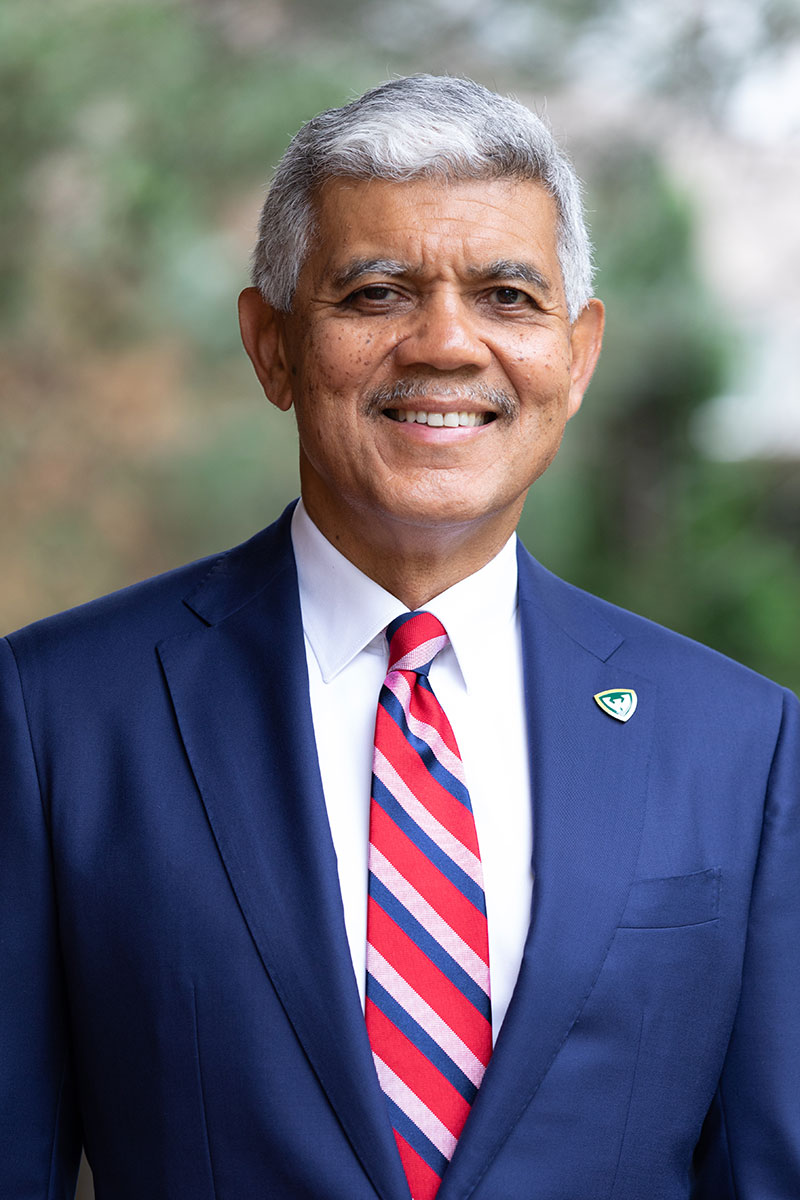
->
245, 179, 602, 545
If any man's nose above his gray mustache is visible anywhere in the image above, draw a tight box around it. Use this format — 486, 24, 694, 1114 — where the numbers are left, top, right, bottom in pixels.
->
395, 293, 492, 371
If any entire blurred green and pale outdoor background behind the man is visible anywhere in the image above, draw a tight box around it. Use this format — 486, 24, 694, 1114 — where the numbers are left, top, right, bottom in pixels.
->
0, 0, 800, 1198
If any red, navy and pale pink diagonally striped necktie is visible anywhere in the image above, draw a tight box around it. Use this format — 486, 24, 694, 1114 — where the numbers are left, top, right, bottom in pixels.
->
366, 612, 492, 1200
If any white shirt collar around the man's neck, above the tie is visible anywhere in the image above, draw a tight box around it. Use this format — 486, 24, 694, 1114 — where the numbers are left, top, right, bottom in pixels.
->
291, 500, 517, 688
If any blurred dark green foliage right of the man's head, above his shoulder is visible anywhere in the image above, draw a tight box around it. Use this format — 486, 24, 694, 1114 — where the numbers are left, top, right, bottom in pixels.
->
521, 143, 800, 690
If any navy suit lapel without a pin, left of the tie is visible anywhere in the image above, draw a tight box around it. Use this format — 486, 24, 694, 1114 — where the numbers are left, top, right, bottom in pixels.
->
158, 514, 407, 1198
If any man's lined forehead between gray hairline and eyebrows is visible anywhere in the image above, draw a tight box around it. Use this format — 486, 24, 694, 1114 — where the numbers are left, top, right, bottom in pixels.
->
301, 179, 560, 283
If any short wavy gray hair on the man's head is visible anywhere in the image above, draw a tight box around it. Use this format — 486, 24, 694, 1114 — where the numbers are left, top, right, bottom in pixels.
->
252, 74, 593, 320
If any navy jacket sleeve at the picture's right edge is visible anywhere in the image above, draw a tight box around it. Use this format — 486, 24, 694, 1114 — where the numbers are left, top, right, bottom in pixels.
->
692, 692, 800, 1200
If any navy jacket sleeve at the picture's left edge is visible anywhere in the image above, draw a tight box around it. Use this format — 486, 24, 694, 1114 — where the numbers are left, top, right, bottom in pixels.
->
0, 640, 80, 1200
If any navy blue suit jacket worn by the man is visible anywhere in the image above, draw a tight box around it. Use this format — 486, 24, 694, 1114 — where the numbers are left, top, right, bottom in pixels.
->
0, 501, 800, 1200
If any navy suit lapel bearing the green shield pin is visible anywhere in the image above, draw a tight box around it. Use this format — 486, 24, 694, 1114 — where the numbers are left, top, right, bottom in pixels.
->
439, 551, 655, 1200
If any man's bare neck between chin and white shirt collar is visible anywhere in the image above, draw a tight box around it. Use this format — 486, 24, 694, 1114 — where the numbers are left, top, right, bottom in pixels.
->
298, 493, 522, 610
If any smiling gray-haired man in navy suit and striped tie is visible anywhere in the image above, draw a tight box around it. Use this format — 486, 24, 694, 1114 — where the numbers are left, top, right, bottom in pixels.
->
0, 77, 800, 1200
